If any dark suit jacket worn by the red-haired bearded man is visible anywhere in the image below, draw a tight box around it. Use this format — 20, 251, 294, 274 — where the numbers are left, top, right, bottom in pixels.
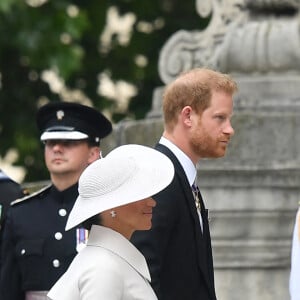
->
131, 144, 216, 300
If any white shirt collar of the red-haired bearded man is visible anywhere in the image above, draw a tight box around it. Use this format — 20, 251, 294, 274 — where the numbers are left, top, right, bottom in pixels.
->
159, 136, 197, 186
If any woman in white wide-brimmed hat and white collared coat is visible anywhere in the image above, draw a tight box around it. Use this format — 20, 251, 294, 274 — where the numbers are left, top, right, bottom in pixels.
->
48, 145, 174, 300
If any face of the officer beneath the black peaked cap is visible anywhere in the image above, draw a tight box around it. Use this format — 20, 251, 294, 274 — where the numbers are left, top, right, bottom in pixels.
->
44, 140, 100, 176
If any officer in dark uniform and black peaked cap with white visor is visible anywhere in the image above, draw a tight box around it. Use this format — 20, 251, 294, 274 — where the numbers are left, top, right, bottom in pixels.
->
0, 102, 112, 300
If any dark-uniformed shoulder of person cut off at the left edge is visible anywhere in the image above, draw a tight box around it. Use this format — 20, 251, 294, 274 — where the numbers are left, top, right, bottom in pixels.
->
0, 169, 27, 270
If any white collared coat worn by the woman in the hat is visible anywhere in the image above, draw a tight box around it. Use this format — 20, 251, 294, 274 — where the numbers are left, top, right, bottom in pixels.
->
48, 225, 157, 300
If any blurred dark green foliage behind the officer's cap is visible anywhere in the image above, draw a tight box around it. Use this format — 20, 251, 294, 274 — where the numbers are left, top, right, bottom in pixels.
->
0, 0, 207, 182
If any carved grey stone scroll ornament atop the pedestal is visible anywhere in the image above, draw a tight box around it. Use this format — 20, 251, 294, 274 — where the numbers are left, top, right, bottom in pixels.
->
159, 0, 300, 84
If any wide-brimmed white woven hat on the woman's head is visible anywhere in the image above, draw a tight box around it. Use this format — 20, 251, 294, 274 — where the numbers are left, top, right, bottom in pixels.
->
66, 144, 174, 230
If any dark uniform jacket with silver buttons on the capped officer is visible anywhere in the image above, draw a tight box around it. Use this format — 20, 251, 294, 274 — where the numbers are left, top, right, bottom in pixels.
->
0, 184, 85, 300
